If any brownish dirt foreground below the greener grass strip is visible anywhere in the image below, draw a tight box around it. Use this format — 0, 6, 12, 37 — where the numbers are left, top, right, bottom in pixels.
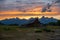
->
0, 29, 60, 40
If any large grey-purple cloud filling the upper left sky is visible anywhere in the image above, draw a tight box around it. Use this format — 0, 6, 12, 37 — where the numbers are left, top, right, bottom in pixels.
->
0, 0, 44, 12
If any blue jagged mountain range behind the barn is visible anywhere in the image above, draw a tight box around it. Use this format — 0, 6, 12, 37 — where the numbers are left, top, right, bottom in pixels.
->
0, 16, 57, 25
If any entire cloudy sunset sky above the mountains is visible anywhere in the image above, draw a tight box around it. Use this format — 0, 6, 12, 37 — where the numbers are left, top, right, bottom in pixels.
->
0, 0, 60, 19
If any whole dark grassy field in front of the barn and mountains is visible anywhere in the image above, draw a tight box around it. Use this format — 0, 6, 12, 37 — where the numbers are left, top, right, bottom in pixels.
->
0, 25, 60, 40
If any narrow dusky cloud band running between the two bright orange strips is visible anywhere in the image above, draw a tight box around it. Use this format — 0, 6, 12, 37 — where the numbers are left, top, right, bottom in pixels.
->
0, 13, 60, 17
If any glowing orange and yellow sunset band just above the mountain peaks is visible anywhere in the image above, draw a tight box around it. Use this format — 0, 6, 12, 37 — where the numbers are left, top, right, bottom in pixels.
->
0, 11, 60, 20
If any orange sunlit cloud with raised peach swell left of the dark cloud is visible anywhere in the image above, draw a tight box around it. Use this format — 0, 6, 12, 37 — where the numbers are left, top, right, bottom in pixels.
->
0, 6, 59, 19
